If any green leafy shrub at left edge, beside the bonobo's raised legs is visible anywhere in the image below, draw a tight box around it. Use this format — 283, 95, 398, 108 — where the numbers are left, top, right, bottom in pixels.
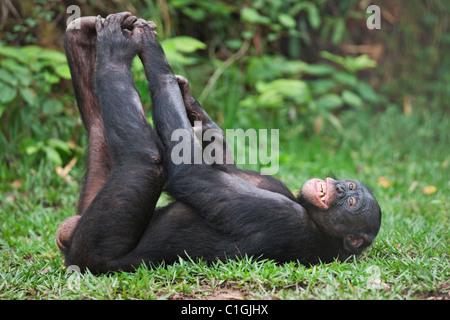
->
0, 46, 76, 170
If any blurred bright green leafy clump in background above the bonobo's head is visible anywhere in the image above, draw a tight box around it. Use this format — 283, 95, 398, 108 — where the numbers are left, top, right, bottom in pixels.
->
240, 51, 382, 133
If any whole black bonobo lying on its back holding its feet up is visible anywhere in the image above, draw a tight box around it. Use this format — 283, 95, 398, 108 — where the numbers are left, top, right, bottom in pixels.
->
57, 13, 381, 272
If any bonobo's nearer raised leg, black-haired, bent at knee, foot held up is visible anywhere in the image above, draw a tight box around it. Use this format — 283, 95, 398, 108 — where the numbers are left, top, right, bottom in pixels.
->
61, 13, 164, 272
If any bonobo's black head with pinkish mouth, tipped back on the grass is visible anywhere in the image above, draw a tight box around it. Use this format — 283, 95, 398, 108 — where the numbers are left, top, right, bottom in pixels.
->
298, 178, 381, 254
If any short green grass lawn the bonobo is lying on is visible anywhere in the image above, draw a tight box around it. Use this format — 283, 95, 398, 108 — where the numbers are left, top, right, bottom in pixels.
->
0, 110, 450, 299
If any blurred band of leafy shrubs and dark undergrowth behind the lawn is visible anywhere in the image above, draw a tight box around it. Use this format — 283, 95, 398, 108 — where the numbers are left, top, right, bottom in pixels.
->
0, 0, 450, 170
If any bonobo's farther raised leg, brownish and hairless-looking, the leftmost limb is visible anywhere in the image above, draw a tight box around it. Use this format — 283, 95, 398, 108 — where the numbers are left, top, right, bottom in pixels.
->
56, 16, 136, 250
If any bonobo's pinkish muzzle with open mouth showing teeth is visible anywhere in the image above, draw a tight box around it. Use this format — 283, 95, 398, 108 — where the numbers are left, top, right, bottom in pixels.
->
301, 178, 336, 210
